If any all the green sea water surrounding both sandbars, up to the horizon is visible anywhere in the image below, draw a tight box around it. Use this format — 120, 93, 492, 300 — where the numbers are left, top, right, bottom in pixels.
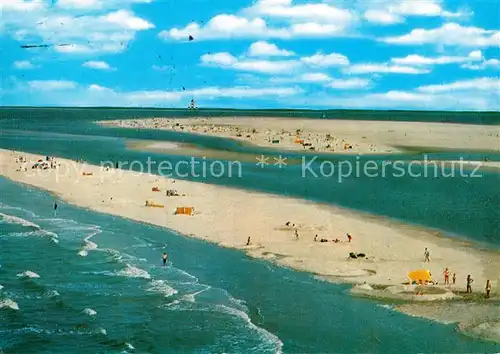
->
0, 108, 500, 353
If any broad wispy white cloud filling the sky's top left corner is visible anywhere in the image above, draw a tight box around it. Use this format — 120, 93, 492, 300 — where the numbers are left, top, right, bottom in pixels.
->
0, 0, 154, 53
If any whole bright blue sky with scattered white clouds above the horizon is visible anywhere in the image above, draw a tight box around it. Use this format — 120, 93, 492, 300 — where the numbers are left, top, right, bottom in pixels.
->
0, 0, 500, 111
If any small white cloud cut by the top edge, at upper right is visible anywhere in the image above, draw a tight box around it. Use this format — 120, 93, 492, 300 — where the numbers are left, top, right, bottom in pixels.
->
364, 0, 470, 25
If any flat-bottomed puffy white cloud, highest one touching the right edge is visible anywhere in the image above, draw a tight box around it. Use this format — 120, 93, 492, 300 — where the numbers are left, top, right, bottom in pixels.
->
381, 23, 500, 47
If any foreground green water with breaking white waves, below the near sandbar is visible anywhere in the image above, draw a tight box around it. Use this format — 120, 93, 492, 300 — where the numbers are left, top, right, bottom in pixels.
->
0, 179, 500, 353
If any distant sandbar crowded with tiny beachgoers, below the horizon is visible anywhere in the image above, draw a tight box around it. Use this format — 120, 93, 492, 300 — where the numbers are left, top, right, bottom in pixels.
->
99, 117, 500, 154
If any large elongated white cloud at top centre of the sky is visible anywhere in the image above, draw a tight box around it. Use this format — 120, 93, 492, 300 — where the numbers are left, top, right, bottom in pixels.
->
159, 0, 355, 41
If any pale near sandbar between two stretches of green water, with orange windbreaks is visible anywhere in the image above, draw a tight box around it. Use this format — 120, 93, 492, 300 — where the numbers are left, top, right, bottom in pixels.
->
0, 149, 500, 289
